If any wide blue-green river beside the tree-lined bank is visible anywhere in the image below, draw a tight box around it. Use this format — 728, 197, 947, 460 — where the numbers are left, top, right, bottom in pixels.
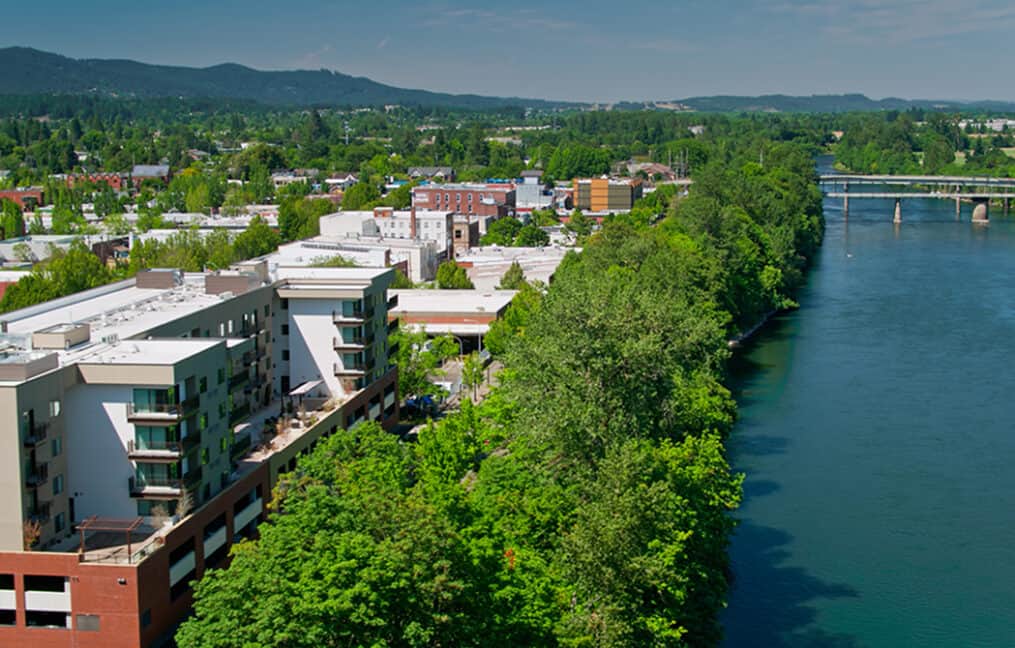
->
723, 159, 1015, 647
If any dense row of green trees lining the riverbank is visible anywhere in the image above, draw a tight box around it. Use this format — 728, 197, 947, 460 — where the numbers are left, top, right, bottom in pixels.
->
177, 126, 822, 648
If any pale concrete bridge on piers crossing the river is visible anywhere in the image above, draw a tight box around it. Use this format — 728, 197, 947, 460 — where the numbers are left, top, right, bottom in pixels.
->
820, 174, 1015, 222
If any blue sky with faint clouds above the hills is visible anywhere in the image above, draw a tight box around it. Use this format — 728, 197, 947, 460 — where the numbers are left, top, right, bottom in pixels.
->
0, 0, 1015, 102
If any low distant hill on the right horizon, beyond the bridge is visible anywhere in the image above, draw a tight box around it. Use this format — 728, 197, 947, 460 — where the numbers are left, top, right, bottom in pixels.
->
672, 94, 1015, 113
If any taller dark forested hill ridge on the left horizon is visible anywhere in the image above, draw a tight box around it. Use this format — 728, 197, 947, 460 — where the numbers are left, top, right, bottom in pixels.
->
0, 47, 577, 110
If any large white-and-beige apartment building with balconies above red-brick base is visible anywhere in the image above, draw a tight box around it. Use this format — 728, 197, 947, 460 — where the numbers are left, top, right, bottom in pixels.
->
0, 261, 398, 648
